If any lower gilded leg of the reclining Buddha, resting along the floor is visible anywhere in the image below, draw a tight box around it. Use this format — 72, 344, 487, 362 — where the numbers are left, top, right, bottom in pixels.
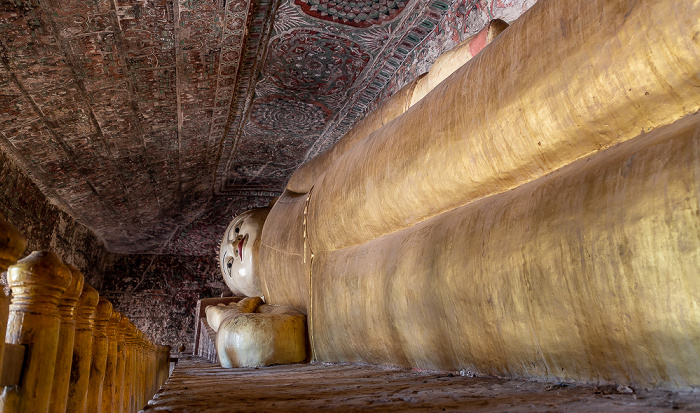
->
312, 115, 700, 388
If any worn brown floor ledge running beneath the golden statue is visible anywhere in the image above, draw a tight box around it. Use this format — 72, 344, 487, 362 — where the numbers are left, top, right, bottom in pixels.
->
144, 357, 700, 413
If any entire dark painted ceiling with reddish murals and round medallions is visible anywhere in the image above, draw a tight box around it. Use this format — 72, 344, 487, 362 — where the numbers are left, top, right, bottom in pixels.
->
0, 0, 524, 255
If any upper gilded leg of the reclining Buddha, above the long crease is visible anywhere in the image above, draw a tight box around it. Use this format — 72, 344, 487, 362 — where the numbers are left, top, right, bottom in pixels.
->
309, 0, 700, 252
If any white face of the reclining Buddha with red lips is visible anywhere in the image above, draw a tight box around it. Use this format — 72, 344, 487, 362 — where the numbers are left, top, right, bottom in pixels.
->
219, 208, 270, 297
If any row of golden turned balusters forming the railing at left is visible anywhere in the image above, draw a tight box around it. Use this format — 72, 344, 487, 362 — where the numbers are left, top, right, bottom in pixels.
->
0, 214, 170, 413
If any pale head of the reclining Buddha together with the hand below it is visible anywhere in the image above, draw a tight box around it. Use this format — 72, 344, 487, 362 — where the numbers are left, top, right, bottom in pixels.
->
205, 208, 307, 368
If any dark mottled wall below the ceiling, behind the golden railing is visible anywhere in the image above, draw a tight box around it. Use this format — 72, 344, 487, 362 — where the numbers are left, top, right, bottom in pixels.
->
0, 146, 226, 348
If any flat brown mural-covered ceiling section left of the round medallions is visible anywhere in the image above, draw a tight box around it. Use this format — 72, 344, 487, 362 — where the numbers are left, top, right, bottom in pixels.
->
0, 0, 273, 253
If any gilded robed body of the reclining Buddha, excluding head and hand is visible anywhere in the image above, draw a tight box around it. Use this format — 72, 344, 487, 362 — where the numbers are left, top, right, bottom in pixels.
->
211, 0, 700, 388
